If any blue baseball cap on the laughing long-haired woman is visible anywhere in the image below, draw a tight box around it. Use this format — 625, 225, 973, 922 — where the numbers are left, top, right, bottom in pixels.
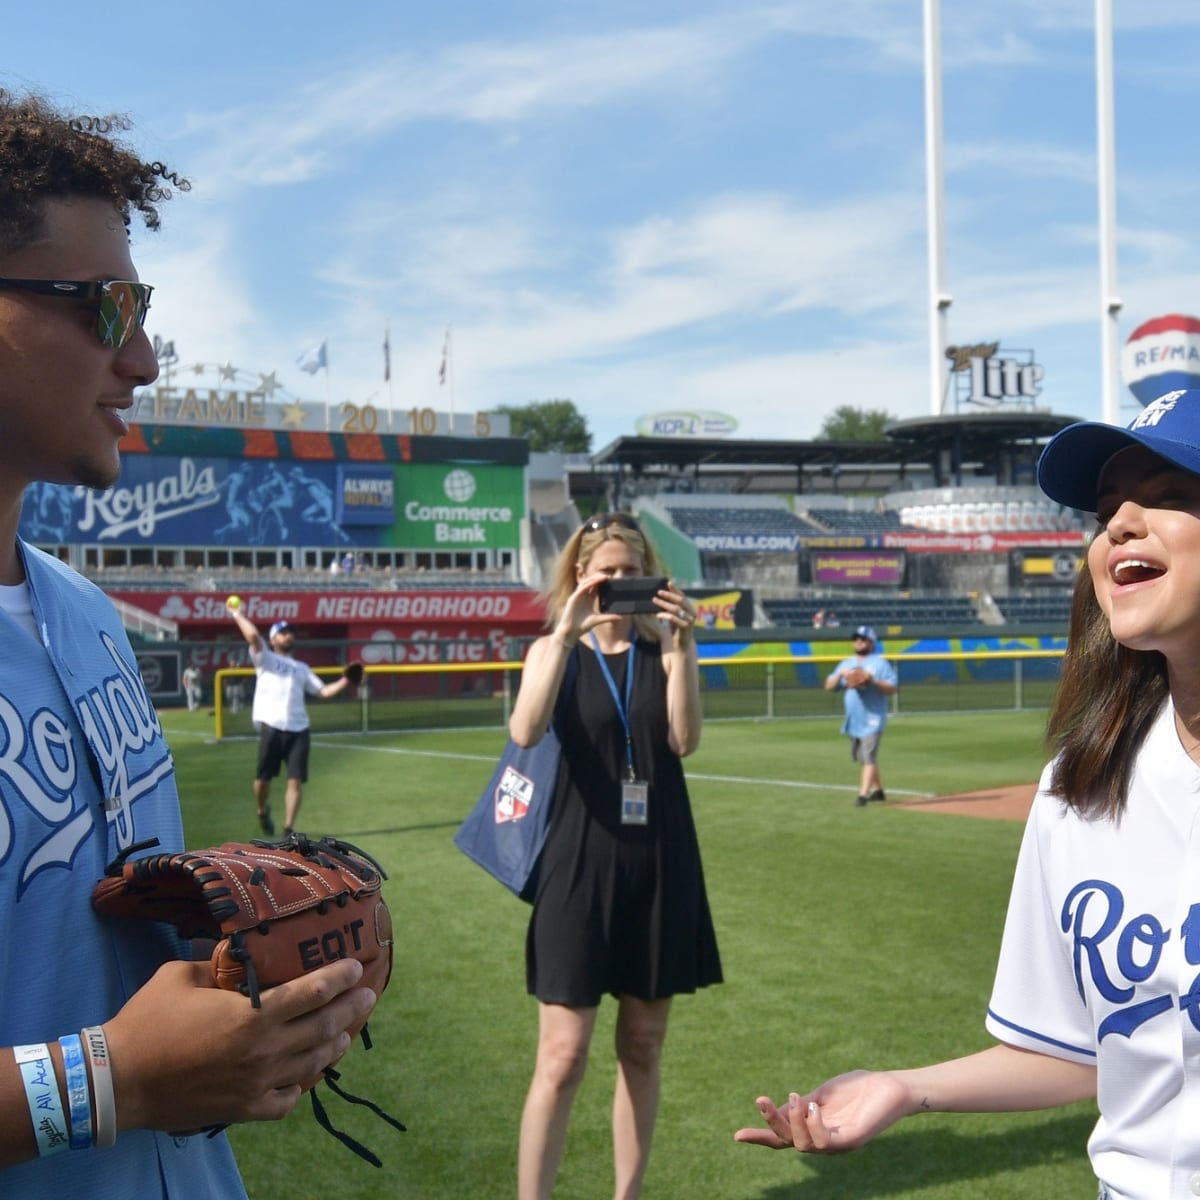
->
1038, 390, 1200, 512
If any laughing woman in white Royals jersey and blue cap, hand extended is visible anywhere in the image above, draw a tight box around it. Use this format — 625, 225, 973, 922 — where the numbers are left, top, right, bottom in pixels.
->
736, 391, 1200, 1200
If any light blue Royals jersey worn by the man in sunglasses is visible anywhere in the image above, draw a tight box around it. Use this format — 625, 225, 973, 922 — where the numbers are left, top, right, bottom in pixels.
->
0, 544, 246, 1200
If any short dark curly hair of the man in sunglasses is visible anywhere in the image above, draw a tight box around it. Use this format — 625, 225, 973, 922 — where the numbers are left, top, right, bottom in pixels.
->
0, 88, 191, 254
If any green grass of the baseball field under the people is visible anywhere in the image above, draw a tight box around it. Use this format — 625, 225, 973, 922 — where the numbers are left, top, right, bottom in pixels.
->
163, 706, 1094, 1200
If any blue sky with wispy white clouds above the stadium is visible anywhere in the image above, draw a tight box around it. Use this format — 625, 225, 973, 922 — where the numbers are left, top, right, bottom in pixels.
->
0, 0, 1200, 449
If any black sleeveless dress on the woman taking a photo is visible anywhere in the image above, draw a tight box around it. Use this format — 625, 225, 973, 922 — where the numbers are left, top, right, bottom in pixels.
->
526, 640, 721, 1008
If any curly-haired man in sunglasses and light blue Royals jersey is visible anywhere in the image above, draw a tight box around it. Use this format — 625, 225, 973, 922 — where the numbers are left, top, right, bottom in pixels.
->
0, 90, 376, 1200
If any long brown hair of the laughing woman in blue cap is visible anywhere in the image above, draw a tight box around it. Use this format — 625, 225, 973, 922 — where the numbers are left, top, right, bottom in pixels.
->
1046, 549, 1168, 820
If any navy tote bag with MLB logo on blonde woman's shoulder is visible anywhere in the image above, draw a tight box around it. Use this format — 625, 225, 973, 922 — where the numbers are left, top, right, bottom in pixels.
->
454, 648, 580, 904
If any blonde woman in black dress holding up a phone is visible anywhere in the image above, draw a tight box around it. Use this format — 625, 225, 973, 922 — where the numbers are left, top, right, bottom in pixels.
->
509, 512, 721, 1200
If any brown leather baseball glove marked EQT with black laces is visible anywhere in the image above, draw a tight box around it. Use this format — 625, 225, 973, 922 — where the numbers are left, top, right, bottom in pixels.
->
91, 833, 392, 1033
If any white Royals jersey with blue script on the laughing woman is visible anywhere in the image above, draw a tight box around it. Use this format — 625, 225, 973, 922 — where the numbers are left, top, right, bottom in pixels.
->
986, 703, 1200, 1200
